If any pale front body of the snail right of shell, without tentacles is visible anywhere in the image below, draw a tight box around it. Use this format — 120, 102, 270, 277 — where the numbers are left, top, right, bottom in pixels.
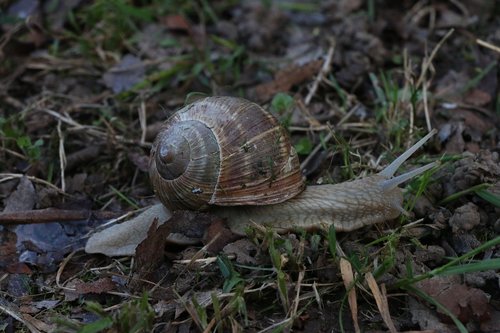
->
218, 175, 403, 235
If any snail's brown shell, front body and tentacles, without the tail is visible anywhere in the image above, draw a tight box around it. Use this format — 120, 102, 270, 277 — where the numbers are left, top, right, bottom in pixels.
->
149, 97, 436, 234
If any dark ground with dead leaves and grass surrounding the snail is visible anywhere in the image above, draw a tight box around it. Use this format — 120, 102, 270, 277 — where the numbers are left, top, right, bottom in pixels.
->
0, 0, 500, 332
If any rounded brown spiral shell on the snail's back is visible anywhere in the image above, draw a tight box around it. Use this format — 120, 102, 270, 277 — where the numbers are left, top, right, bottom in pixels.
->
150, 97, 304, 209
